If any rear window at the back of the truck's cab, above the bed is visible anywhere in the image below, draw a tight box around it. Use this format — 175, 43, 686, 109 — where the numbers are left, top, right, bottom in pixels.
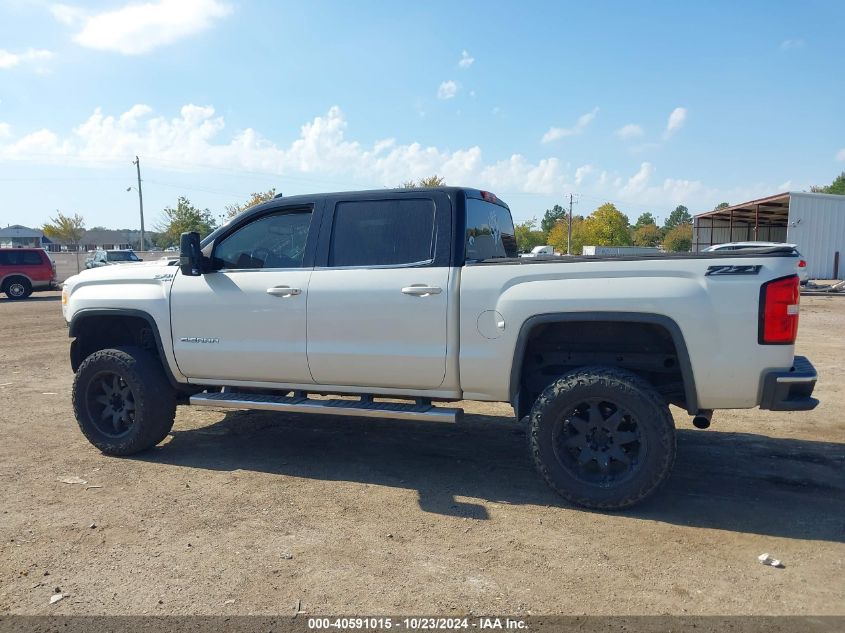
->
465, 197, 517, 262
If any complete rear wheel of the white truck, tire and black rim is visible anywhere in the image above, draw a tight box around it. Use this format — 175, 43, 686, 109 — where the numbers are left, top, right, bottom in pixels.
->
528, 367, 675, 510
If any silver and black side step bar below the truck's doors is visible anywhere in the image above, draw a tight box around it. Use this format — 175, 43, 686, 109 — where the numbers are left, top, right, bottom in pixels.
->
190, 391, 464, 422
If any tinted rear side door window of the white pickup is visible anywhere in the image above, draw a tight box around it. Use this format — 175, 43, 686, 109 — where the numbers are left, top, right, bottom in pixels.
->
329, 198, 435, 267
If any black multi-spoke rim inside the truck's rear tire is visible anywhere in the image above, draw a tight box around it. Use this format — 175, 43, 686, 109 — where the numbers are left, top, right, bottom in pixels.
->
553, 398, 648, 487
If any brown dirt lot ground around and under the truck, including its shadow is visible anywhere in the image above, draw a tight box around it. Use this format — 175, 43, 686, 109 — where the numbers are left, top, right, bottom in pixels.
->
0, 293, 845, 615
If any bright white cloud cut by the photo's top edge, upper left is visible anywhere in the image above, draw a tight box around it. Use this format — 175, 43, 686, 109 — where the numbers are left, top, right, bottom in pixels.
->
51, 0, 232, 55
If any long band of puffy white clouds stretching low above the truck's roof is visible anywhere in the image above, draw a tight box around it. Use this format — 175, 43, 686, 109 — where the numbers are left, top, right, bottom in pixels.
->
0, 104, 774, 215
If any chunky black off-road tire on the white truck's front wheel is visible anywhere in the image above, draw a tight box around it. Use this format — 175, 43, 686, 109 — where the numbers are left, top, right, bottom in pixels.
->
73, 347, 176, 455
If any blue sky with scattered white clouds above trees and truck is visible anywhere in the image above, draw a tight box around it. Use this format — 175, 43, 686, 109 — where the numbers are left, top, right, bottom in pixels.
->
0, 0, 845, 228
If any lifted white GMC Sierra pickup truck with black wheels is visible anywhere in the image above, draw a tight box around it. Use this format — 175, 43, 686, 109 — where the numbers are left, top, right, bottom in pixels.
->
62, 187, 818, 509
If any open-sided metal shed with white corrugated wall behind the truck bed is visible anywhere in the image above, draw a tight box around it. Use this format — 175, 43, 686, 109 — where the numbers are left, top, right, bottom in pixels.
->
692, 191, 845, 279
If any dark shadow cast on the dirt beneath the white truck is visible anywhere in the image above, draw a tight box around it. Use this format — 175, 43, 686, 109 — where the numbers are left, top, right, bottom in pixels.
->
137, 411, 845, 542
